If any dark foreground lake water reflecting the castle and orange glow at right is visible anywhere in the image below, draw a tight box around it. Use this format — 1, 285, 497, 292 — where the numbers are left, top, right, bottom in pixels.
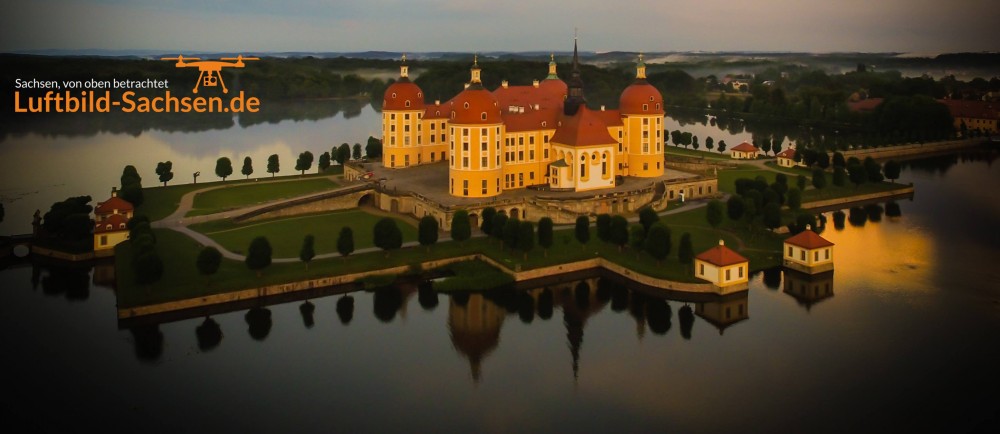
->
0, 151, 1000, 433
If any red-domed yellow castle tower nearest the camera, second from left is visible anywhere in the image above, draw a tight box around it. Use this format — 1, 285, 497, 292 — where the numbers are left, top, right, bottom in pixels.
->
448, 58, 505, 197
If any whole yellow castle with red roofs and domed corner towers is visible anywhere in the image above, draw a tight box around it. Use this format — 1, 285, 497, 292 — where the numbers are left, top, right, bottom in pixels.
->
382, 41, 664, 198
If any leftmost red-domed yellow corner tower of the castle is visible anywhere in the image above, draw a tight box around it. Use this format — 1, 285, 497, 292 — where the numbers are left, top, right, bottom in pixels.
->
382, 54, 424, 168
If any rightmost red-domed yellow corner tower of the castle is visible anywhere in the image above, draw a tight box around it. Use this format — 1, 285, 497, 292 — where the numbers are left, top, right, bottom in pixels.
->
618, 54, 664, 178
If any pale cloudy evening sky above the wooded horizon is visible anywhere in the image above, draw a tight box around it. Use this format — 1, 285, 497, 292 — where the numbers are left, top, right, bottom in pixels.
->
0, 0, 1000, 53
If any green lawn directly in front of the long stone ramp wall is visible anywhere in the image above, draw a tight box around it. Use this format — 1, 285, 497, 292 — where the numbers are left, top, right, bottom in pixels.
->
191, 210, 417, 258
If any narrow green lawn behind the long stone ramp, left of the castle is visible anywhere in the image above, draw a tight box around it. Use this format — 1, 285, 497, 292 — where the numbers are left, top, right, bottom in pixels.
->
187, 177, 338, 217
